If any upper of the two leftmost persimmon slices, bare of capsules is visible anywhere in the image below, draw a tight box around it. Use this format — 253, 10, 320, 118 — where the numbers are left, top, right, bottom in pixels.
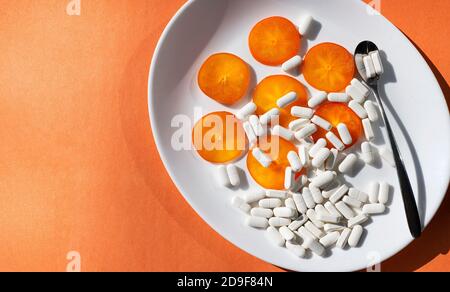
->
198, 53, 250, 105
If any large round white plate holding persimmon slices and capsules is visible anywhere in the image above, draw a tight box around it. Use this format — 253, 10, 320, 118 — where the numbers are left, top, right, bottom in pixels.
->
149, 0, 450, 271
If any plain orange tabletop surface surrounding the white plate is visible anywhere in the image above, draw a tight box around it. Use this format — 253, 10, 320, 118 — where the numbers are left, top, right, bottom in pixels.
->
0, 0, 450, 271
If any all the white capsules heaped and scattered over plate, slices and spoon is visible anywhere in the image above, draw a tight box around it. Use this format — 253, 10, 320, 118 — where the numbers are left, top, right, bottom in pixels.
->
217, 16, 395, 257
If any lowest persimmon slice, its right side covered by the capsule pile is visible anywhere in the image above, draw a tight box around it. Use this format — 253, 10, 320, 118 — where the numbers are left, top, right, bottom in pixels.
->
247, 136, 297, 190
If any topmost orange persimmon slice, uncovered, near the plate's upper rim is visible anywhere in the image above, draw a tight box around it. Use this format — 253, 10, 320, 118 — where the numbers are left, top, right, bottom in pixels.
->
248, 16, 301, 66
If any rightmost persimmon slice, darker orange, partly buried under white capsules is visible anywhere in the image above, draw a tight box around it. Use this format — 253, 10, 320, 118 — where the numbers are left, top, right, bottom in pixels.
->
313, 102, 363, 148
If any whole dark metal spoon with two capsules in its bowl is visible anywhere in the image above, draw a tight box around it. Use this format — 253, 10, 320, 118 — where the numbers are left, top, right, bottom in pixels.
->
355, 41, 422, 238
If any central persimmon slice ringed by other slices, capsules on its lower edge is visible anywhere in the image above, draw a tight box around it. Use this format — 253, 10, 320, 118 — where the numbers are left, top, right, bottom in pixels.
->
253, 75, 308, 127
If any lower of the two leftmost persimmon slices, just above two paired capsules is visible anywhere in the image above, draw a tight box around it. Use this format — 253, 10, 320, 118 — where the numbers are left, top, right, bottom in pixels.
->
192, 112, 246, 163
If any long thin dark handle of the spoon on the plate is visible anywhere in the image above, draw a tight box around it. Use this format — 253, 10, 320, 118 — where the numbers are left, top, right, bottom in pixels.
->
371, 86, 422, 238
